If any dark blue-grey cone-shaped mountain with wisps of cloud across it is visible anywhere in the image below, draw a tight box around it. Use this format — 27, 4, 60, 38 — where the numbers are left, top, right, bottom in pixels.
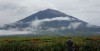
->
0, 9, 100, 34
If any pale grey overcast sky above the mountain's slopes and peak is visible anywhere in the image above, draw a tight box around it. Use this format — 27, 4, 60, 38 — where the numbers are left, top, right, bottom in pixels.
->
0, 0, 100, 26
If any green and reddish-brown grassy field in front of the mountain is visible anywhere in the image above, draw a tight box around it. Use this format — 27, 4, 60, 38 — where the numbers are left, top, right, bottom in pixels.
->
0, 36, 100, 51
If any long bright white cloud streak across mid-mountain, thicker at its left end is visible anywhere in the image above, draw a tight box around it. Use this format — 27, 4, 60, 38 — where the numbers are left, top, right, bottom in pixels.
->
31, 17, 74, 28
